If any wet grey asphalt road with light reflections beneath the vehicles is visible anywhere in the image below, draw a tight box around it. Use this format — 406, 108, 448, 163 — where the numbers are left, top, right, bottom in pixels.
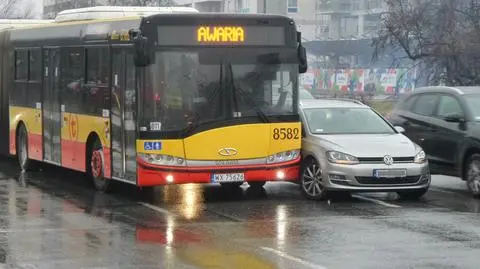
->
0, 156, 480, 269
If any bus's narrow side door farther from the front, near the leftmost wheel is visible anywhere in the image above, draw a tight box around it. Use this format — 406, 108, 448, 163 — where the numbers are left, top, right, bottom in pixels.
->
42, 49, 62, 164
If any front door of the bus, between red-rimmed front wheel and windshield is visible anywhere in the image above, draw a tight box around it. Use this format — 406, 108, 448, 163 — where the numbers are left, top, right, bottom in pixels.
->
111, 48, 137, 183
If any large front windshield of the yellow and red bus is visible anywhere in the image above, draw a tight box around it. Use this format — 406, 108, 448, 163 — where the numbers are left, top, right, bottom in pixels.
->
140, 48, 298, 131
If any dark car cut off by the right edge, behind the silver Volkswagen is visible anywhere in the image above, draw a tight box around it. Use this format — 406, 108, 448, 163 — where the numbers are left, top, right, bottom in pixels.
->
387, 86, 480, 197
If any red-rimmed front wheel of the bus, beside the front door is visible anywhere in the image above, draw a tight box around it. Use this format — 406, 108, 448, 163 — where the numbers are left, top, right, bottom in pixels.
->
89, 140, 111, 193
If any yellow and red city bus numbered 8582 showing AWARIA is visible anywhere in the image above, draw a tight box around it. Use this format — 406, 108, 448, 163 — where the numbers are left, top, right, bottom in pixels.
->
0, 7, 307, 191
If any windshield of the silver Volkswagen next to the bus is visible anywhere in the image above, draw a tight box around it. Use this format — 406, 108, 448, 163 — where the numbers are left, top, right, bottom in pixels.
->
304, 108, 396, 134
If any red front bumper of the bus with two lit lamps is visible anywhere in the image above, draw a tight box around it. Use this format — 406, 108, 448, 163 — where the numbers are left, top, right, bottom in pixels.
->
137, 159, 300, 187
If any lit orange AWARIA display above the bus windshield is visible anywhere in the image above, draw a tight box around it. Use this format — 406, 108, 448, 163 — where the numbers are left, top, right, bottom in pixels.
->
157, 25, 286, 46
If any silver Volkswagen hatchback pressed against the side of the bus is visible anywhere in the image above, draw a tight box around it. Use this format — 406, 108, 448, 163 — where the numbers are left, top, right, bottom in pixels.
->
299, 99, 430, 200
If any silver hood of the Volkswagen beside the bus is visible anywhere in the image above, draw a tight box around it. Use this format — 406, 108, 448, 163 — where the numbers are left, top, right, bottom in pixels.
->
314, 134, 418, 157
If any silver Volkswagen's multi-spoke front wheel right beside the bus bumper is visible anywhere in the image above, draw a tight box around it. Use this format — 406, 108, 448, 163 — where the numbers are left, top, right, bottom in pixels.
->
300, 158, 328, 200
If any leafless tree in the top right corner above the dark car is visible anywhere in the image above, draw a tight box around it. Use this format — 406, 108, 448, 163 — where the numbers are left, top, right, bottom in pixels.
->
373, 0, 480, 85
